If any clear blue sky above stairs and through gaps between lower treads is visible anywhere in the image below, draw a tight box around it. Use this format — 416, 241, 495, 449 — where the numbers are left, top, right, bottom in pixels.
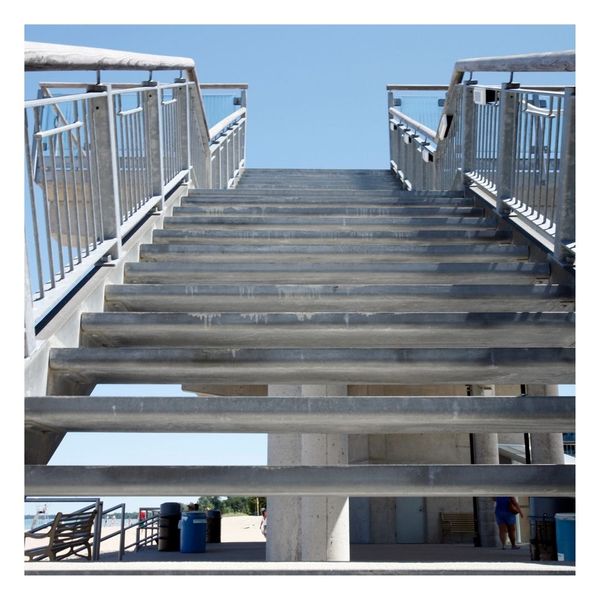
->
21, 18, 575, 510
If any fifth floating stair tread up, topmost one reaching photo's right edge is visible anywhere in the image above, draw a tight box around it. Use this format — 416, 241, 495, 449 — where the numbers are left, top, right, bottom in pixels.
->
104, 282, 573, 312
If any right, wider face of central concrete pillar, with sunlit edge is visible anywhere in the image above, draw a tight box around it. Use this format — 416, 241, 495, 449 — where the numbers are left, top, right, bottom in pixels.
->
301, 385, 350, 561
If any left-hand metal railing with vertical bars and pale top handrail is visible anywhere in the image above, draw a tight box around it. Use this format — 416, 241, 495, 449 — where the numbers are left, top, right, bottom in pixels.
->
25, 42, 247, 346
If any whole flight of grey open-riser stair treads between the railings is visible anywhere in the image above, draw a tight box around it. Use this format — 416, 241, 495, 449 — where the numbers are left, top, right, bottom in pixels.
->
26, 169, 574, 502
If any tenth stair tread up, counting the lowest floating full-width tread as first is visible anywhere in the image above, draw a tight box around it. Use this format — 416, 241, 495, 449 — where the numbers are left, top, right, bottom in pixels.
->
173, 202, 483, 217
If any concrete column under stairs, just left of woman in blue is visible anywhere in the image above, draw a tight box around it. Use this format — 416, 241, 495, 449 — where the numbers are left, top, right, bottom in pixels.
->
473, 385, 500, 548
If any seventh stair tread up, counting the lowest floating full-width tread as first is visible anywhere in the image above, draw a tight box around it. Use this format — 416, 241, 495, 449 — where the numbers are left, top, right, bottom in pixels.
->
140, 240, 529, 263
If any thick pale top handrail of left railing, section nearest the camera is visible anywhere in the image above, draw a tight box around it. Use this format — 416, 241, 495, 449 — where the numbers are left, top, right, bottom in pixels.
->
25, 42, 195, 71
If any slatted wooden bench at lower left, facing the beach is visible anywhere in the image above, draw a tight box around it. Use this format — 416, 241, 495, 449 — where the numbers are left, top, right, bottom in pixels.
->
25, 510, 96, 560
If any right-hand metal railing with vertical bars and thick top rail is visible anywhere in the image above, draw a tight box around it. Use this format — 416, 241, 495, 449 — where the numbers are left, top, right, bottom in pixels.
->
387, 51, 575, 264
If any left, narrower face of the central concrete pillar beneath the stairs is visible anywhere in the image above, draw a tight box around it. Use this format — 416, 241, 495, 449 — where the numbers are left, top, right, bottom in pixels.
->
266, 385, 302, 562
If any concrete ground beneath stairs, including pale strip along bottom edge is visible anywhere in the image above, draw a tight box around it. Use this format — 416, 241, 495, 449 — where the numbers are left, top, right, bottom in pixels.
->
25, 542, 575, 575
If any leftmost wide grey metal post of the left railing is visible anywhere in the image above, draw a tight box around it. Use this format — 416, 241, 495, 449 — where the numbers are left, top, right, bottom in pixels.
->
88, 84, 121, 259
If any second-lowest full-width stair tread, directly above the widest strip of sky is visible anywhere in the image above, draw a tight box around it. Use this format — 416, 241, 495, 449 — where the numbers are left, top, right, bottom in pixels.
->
25, 396, 575, 434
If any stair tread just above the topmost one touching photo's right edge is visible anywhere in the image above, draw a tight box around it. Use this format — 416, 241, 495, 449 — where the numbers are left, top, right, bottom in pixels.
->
124, 259, 549, 284
